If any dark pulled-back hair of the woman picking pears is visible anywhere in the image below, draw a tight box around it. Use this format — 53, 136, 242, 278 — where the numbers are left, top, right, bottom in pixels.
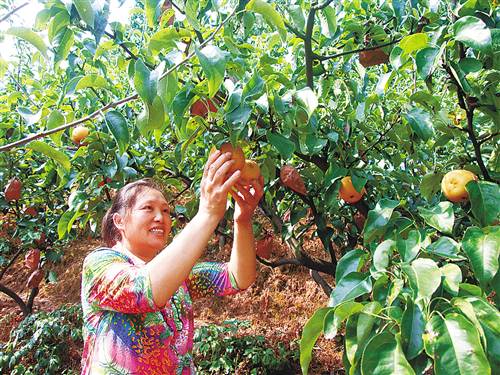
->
101, 178, 164, 247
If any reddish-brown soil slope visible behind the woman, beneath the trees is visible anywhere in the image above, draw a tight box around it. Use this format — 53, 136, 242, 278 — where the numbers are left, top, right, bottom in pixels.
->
0, 238, 343, 374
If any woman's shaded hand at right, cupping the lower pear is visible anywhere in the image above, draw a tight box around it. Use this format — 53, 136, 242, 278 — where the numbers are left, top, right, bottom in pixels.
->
230, 176, 264, 222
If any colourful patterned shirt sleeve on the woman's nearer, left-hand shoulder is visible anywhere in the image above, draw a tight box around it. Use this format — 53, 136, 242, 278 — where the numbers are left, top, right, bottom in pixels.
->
82, 248, 160, 314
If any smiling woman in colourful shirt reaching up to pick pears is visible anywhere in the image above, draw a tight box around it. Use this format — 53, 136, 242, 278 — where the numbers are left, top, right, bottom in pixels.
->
82, 151, 263, 375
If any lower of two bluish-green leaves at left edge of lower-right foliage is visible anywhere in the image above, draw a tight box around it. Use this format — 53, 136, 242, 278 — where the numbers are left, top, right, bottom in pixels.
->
328, 272, 372, 307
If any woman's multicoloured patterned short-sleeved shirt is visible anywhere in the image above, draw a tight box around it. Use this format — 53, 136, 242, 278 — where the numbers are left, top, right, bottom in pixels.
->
82, 248, 239, 375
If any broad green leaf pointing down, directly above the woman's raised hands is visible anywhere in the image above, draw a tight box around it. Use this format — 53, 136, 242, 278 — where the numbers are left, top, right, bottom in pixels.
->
196, 45, 226, 98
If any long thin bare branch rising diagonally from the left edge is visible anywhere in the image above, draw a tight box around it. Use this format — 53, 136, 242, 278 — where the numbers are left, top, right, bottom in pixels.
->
0, 9, 240, 152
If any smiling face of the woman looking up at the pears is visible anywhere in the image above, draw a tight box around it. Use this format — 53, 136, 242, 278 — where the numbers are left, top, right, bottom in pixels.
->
114, 188, 172, 261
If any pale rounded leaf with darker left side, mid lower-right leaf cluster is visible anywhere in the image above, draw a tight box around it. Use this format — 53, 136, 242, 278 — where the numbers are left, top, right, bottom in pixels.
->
403, 258, 441, 300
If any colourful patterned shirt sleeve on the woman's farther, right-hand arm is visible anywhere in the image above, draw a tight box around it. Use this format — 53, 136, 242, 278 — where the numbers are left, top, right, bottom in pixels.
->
187, 262, 241, 299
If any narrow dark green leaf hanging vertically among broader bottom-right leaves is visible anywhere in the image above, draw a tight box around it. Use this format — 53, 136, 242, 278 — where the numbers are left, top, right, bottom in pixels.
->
401, 300, 425, 359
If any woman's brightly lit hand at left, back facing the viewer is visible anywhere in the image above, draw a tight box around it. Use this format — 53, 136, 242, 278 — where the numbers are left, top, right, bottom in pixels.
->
199, 150, 241, 220
